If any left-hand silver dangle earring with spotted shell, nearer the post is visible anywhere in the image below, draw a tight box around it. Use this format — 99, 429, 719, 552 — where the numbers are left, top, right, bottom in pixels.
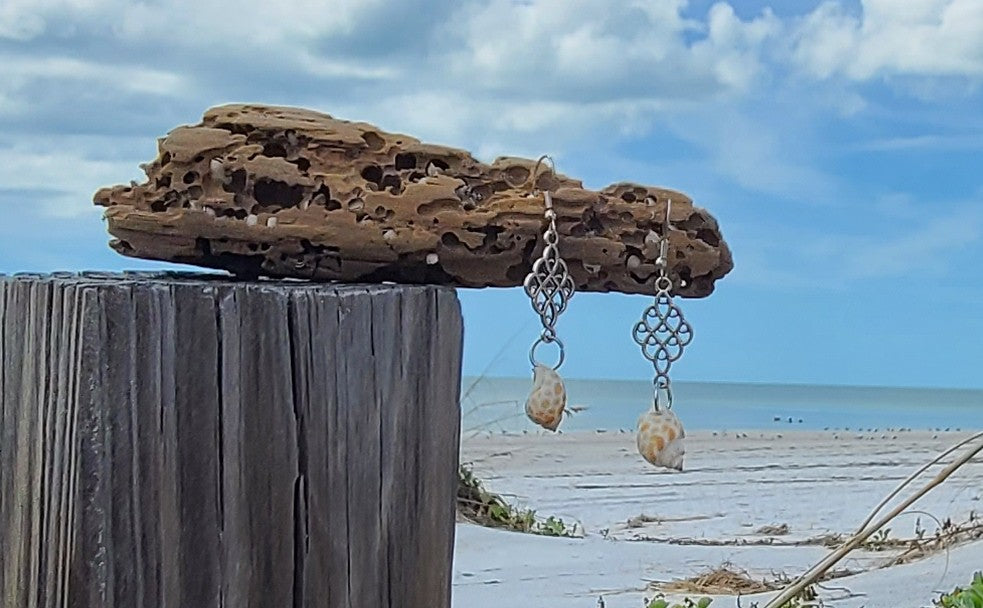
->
522, 156, 575, 431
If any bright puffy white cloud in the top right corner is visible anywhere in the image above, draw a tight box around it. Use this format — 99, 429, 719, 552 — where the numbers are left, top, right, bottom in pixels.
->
792, 0, 983, 81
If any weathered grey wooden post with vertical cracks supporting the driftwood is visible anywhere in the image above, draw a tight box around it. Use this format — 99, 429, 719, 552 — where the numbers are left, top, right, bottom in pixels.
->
0, 275, 461, 608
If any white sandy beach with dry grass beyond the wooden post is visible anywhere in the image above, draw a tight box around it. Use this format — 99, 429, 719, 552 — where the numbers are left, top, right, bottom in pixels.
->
454, 429, 983, 608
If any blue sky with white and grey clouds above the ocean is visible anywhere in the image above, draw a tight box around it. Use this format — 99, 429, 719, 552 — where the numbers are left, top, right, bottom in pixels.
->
0, 0, 983, 388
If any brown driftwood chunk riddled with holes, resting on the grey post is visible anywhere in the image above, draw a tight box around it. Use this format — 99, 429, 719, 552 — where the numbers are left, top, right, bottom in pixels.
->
95, 105, 733, 297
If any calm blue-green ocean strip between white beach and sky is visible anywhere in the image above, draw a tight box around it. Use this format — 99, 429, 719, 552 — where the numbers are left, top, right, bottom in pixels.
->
461, 378, 983, 432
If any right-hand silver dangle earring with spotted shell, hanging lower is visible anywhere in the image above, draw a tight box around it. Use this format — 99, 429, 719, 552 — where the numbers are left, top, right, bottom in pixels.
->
632, 201, 693, 471
